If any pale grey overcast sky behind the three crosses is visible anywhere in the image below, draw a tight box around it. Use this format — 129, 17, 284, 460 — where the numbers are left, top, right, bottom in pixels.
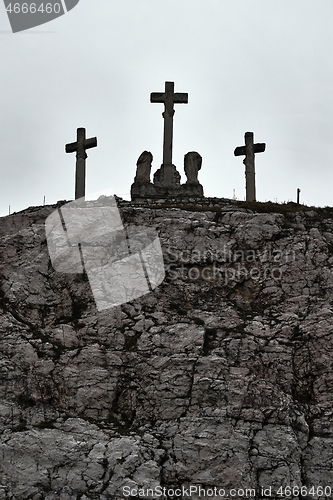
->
0, 0, 333, 216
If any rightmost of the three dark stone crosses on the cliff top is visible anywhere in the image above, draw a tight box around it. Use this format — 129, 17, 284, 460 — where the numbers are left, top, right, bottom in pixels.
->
234, 132, 266, 201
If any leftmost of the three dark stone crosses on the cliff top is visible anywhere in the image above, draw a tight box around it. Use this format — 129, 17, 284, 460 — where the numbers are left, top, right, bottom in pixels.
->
65, 128, 97, 200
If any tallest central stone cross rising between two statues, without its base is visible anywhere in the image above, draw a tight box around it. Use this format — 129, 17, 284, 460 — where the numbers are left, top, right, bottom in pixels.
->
150, 82, 188, 165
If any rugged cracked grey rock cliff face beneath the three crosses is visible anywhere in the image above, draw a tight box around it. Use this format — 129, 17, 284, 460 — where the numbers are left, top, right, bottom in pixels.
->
0, 203, 333, 500
